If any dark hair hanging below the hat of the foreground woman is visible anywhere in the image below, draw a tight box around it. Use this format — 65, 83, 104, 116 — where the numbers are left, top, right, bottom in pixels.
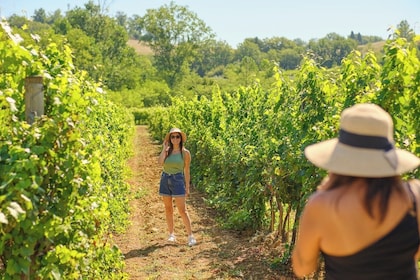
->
328, 174, 403, 223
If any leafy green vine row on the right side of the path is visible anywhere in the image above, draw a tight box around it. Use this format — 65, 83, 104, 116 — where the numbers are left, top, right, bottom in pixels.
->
149, 34, 420, 243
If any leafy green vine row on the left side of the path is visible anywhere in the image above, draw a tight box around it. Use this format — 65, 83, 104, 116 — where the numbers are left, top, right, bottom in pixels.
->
0, 23, 133, 279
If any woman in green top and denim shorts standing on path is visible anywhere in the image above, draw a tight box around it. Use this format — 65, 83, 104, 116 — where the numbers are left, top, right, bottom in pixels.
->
158, 128, 197, 246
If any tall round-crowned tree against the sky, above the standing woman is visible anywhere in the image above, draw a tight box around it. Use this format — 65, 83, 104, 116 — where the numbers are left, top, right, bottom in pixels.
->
136, 1, 214, 88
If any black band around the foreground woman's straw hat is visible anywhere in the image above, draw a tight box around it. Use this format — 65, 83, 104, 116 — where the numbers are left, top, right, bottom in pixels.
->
338, 129, 394, 151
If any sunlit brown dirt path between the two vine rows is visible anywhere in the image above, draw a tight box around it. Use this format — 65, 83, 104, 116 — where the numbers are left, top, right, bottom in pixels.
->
116, 126, 293, 280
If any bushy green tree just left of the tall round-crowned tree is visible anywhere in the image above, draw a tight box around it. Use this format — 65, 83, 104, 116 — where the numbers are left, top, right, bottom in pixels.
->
66, 1, 141, 91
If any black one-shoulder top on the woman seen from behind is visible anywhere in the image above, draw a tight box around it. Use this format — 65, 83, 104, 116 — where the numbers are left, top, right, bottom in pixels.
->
321, 187, 420, 280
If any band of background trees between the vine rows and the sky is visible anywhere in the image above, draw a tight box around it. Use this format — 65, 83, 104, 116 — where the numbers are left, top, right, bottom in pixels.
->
7, 0, 413, 108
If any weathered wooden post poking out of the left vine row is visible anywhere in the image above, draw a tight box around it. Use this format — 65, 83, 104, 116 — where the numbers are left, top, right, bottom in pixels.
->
25, 76, 44, 124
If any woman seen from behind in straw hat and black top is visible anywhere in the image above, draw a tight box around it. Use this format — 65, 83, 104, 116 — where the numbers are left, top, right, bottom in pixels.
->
292, 104, 420, 280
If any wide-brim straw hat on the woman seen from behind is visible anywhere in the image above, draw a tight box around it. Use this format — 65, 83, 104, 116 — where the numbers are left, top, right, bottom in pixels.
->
305, 104, 420, 178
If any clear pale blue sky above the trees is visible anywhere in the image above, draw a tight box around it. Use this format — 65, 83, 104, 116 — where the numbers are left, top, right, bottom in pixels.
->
0, 0, 420, 47
